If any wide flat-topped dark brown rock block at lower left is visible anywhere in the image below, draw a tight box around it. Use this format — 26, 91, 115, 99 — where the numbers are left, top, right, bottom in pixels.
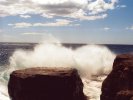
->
8, 68, 86, 100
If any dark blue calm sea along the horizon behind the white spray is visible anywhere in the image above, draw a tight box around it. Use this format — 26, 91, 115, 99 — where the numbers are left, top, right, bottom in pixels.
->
0, 42, 133, 65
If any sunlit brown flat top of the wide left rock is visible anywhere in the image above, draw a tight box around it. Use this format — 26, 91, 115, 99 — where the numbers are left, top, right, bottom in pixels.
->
12, 67, 77, 78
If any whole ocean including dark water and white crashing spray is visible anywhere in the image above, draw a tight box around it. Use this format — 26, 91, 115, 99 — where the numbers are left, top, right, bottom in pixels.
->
0, 43, 133, 100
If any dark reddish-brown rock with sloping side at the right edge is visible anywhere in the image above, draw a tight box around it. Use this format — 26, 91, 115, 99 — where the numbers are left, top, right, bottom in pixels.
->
101, 54, 133, 100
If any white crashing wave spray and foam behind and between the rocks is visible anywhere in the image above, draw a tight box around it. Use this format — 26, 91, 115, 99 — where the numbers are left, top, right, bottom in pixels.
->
0, 42, 115, 100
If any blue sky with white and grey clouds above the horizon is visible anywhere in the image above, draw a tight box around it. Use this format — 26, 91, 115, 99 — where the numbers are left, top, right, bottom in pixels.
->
0, 0, 133, 44
